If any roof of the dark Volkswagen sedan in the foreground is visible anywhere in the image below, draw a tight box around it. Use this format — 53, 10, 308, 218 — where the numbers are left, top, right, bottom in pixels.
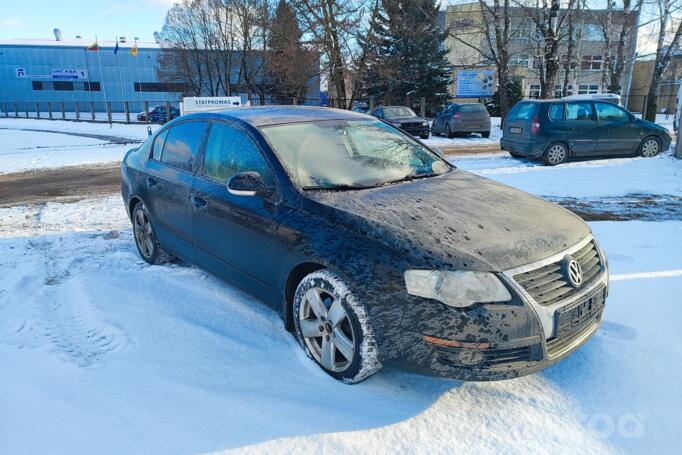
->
182, 106, 374, 127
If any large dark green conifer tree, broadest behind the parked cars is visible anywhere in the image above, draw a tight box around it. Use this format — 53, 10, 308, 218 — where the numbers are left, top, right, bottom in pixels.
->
364, 0, 451, 111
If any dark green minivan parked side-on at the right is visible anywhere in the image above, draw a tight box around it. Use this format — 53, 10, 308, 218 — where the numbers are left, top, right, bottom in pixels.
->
500, 100, 671, 166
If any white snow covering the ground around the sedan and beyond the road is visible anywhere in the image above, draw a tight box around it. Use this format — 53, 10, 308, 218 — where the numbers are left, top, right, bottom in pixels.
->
0, 119, 682, 454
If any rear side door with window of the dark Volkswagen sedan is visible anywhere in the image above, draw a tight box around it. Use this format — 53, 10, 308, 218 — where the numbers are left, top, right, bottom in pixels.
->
145, 121, 208, 258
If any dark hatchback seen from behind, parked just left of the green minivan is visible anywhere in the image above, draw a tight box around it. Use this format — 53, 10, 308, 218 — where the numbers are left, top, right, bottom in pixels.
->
431, 103, 490, 138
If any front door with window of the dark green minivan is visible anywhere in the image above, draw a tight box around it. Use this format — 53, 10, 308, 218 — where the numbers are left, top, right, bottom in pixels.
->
594, 101, 643, 155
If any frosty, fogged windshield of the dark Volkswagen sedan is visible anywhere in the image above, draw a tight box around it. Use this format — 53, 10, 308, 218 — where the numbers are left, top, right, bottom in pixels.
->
261, 120, 451, 189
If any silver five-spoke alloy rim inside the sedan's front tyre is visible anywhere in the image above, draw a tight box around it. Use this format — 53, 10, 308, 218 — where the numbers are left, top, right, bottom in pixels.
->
299, 288, 355, 373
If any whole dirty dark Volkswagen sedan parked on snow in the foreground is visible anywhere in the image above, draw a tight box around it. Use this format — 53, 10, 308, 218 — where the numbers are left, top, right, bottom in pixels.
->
121, 107, 608, 383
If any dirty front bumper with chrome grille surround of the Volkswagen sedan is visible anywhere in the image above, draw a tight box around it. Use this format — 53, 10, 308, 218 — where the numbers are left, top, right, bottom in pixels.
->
386, 237, 608, 381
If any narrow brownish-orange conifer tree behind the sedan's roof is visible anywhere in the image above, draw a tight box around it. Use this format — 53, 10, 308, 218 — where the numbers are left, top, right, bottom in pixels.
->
268, 0, 315, 104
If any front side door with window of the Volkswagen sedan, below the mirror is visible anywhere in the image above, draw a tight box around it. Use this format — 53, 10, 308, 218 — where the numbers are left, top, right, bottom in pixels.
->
190, 122, 285, 299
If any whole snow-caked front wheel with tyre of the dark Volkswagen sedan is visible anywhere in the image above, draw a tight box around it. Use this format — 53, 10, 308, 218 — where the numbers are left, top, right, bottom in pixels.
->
293, 269, 381, 384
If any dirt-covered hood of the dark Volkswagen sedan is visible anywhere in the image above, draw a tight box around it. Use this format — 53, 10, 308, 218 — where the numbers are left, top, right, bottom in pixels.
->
306, 170, 590, 272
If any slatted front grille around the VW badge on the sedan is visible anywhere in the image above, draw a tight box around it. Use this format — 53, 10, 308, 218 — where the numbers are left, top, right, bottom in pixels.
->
514, 240, 602, 305
